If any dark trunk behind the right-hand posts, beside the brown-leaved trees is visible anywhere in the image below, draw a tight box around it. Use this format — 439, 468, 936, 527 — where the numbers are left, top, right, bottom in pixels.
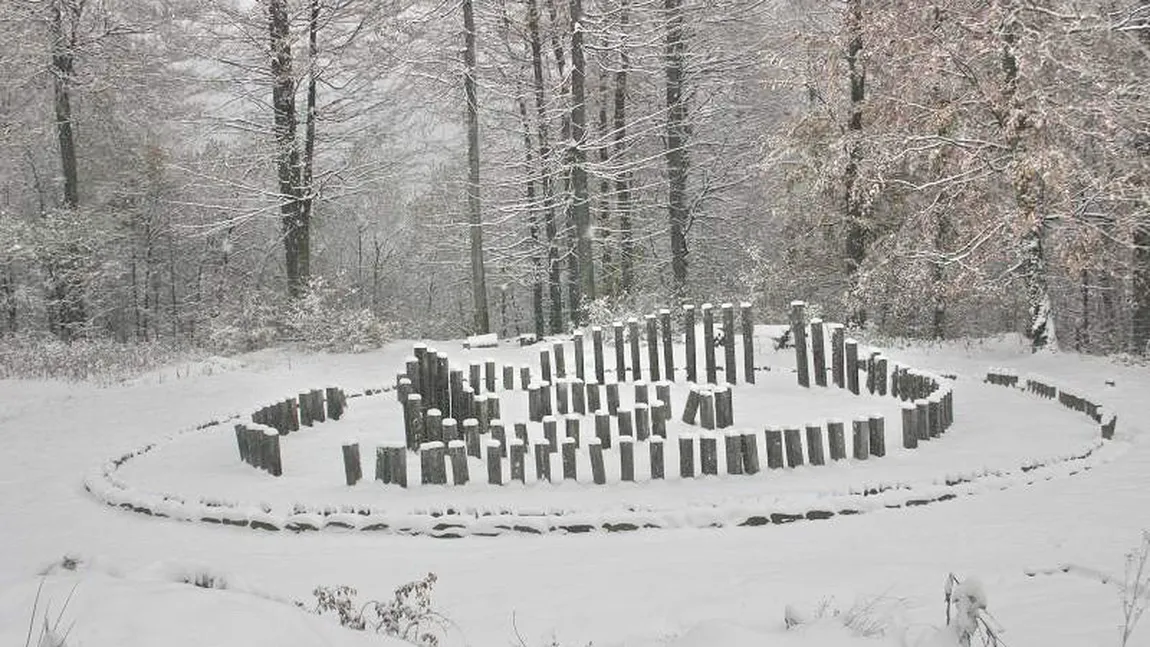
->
843, 0, 867, 325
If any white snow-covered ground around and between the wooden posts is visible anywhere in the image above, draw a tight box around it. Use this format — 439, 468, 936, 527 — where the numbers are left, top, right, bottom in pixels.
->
0, 330, 1150, 647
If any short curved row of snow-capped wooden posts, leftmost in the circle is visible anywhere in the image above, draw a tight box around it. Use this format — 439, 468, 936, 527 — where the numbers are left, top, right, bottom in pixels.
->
228, 386, 347, 476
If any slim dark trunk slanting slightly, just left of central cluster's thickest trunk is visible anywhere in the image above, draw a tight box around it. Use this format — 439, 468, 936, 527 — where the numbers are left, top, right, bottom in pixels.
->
527, 0, 564, 333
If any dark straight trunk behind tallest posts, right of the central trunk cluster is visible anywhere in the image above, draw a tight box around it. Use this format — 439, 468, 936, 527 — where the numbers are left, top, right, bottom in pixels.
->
664, 0, 690, 300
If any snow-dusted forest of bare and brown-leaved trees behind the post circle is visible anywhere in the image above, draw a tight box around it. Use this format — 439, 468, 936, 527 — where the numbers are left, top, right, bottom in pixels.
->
0, 0, 1150, 363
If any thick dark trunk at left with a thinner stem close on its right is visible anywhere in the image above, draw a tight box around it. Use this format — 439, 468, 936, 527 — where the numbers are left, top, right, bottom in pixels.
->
268, 0, 308, 298
